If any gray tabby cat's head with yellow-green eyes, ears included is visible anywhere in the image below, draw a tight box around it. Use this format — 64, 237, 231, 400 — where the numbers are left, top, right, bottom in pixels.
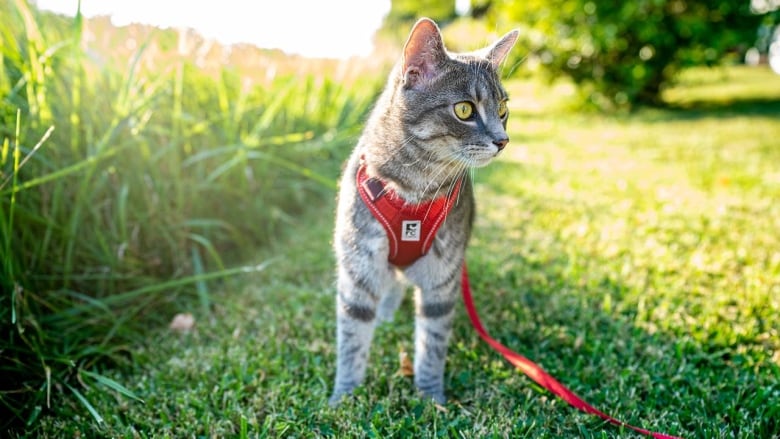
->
395, 18, 518, 167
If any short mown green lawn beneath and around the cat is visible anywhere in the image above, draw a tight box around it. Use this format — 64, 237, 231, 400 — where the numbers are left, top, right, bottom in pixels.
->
29, 68, 780, 438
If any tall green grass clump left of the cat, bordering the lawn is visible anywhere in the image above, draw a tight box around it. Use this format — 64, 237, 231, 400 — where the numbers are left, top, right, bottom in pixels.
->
0, 0, 378, 431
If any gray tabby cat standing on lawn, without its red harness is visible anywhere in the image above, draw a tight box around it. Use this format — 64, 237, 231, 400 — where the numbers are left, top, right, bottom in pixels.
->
330, 19, 518, 406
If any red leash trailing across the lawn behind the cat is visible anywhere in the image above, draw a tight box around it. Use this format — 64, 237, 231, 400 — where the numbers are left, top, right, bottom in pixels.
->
461, 263, 680, 439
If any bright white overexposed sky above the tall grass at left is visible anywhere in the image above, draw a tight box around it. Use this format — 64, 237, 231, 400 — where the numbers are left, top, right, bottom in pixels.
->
37, 0, 390, 58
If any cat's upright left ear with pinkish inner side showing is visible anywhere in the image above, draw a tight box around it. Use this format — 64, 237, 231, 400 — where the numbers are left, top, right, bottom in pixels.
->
403, 18, 447, 88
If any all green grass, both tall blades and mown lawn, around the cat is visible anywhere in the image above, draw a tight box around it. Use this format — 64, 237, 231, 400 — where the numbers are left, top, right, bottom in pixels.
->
0, 0, 780, 438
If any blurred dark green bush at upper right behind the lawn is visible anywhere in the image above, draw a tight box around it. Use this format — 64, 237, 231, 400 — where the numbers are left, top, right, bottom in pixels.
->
492, 0, 762, 108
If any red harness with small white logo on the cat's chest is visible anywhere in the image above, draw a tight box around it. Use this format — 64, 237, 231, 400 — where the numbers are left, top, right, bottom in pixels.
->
357, 164, 461, 267
